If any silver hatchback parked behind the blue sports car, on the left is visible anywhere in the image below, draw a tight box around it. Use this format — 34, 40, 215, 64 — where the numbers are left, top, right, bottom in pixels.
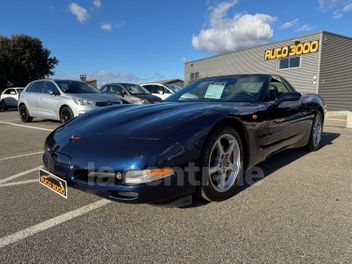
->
18, 79, 123, 123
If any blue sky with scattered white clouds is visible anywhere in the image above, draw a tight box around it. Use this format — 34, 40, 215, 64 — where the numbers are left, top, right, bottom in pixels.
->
0, 0, 352, 84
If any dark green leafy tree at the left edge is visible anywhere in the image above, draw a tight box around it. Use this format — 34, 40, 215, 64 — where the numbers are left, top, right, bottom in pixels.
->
0, 35, 59, 90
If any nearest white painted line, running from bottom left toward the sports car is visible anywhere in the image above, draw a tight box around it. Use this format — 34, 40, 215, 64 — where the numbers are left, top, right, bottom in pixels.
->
0, 199, 111, 248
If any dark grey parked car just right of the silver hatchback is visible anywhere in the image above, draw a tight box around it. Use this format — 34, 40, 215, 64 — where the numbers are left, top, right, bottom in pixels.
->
100, 83, 161, 104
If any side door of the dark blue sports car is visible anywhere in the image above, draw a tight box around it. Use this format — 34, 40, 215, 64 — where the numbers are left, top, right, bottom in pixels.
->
267, 78, 307, 151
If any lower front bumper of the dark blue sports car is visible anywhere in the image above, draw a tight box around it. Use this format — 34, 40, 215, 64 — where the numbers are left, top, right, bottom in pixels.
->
43, 153, 195, 203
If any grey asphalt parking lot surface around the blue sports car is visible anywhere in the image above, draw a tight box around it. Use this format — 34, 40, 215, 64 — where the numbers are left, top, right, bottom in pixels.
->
0, 111, 352, 263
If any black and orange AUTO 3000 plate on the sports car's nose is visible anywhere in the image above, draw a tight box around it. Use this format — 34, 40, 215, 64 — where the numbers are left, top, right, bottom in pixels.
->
39, 169, 67, 199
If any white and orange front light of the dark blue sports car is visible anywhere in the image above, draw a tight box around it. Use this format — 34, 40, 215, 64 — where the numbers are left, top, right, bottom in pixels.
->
125, 168, 174, 184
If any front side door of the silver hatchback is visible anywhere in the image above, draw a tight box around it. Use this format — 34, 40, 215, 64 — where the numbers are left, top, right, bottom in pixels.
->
38, 81, 61, 119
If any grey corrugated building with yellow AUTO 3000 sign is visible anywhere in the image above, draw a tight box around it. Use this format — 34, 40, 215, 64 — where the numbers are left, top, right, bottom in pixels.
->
185, 31, 352, 111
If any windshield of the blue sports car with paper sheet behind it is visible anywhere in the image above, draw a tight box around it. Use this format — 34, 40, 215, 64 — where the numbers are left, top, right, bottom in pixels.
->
165, 75, 267, 102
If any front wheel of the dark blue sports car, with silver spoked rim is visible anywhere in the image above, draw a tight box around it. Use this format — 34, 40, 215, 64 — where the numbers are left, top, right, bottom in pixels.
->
200, 126, 244, 202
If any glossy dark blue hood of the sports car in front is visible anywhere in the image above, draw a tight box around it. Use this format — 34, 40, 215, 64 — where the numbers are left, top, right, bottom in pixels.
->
68, 102, 253, 139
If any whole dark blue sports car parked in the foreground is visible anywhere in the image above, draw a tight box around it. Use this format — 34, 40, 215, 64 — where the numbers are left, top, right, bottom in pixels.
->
43, 75, 325, 203
